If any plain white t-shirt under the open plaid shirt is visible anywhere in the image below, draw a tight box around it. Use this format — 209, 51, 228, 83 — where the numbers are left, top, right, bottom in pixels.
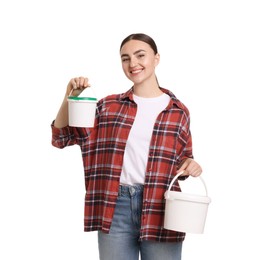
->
120, 93, 170, 185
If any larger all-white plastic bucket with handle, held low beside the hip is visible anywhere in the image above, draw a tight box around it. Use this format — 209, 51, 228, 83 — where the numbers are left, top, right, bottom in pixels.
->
164, 172, 211, 234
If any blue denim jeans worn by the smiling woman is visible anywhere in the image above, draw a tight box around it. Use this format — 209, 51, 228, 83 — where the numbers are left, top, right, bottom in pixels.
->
98, 185, 182, 260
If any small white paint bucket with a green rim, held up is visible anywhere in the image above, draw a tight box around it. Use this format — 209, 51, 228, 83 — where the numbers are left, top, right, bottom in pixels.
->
68, 87, 97, 127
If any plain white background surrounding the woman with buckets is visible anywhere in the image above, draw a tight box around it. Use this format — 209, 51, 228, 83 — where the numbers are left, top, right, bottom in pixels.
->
0, 0, 263, 260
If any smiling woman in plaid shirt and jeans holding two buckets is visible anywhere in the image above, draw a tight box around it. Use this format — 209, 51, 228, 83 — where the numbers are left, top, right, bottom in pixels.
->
52, 34, 202, 260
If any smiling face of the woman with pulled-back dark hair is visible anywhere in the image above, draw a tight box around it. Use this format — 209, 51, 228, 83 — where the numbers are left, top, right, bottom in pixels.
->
120, 40, 160, 84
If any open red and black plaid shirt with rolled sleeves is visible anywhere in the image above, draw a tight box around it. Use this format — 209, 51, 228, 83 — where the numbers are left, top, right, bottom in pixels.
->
51, 88, 193, 242
